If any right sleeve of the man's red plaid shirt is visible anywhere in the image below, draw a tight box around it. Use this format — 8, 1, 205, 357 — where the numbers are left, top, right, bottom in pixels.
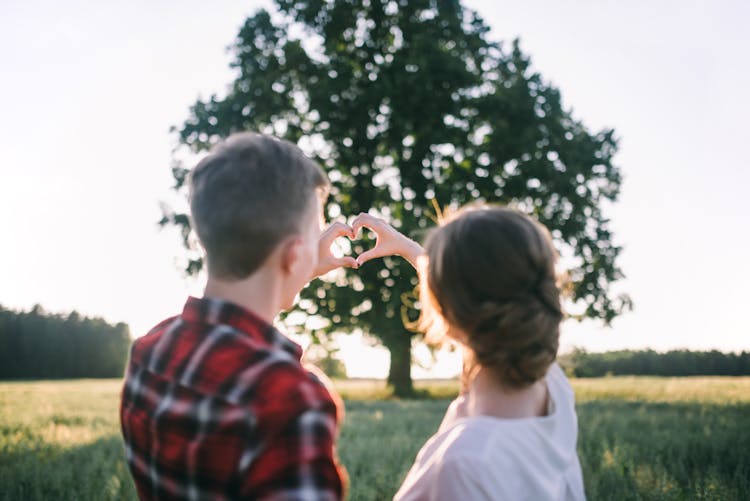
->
241, 371, 346, 501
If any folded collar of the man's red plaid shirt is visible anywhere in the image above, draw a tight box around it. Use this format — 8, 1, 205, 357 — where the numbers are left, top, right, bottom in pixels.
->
182, 296, 302, 360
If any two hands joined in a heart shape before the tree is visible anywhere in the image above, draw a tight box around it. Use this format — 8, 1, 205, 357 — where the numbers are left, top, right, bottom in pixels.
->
319, 213, 405, 271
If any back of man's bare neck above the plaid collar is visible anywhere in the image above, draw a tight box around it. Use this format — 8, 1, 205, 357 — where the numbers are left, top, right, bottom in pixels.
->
203, 269, 281, 324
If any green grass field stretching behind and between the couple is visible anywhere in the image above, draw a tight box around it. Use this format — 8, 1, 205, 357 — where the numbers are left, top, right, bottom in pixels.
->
0, 377, 750, 501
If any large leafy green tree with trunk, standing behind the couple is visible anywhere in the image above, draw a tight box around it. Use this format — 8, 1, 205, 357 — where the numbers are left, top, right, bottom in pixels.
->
162, 0, 628, 394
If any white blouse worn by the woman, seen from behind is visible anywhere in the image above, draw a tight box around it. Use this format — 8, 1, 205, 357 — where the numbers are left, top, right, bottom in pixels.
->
394, 364, 586, 501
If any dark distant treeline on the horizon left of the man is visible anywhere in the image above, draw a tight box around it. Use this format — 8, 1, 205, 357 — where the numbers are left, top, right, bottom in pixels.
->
0, 306, 131, 379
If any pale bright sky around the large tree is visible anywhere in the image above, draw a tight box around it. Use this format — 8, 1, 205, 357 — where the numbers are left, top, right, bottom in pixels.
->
0, 0, 750, 377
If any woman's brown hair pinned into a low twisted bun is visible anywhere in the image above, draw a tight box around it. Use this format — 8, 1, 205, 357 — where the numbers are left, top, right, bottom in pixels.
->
419, 206, 563, 388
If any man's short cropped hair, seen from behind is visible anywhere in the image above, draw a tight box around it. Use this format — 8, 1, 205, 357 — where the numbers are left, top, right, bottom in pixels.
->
190, 132, 330, 279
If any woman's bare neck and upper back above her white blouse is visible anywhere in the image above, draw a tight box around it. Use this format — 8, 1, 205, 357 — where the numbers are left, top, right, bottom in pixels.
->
466, 368, 549, 419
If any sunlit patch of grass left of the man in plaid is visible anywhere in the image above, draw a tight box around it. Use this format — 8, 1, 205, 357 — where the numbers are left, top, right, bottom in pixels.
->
0, 380, 137, 500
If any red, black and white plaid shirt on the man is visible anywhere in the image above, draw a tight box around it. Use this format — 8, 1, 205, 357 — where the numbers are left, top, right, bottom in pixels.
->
120, 297, 345, 500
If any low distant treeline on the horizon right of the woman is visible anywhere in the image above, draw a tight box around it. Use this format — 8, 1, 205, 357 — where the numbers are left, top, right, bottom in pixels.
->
559, 348, 750, 377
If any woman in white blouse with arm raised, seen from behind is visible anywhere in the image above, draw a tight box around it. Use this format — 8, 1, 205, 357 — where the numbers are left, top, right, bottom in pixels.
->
352, 207, 585, 501
